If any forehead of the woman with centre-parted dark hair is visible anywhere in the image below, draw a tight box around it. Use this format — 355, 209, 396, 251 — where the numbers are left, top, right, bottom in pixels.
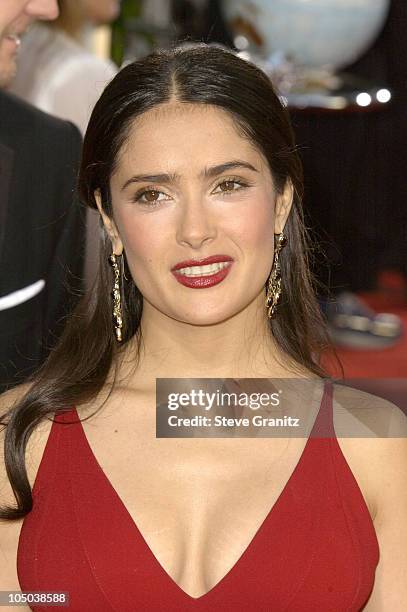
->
116, 102, 268, 178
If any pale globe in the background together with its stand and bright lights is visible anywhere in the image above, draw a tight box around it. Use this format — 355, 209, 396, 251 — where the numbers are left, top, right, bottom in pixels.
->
223, 0, 391, 110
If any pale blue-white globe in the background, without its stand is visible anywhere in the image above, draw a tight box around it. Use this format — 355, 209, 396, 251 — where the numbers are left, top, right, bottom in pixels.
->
223, 0, 390, 71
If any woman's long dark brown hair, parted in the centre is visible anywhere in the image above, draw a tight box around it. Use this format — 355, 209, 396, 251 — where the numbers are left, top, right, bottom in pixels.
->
0, 43, 342, 519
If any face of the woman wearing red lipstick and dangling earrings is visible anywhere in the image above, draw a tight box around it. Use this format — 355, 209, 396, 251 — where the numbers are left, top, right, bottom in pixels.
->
97, 103, 292, 325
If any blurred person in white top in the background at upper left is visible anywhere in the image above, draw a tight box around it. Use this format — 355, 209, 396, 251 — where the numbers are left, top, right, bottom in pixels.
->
11, 0, 120, 133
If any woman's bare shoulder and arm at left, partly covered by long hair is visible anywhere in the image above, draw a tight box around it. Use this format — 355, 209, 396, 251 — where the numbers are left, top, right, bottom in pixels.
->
0, 384, 52, 596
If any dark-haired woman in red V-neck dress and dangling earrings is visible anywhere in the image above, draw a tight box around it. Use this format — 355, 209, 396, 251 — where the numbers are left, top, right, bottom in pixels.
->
0, 44, 407, 612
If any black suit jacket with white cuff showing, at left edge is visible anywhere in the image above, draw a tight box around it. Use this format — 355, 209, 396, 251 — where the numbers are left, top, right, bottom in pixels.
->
0, 91, 85, 391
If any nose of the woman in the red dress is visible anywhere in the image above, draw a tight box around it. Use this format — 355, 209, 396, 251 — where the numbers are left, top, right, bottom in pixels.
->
176, 198, 217, 249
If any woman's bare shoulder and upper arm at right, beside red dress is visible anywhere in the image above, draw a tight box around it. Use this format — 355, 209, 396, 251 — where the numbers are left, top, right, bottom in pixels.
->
337, 381, 407, 612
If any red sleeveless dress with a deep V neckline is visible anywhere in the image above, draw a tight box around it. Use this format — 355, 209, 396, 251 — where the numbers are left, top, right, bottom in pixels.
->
17, 382, 379, 612
